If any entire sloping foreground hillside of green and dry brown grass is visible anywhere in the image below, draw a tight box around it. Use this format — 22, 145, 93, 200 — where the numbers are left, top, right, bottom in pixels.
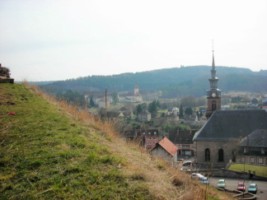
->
0, 84, 232, 199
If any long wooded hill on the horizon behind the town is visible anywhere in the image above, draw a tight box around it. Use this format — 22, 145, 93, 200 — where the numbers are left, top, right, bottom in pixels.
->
42, 66, 267, 97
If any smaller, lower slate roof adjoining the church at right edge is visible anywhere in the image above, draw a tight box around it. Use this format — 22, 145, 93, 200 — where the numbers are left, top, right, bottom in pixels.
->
239, 129, 267, 147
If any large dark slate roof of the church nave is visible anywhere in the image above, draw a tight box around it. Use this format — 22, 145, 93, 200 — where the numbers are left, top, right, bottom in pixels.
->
193, 110, 267, 141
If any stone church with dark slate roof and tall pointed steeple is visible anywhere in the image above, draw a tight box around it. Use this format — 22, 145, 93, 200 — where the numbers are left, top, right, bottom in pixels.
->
193, 51, 267, 168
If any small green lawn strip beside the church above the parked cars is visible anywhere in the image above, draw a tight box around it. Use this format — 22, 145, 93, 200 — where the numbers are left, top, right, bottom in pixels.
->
228, 164, 267, 178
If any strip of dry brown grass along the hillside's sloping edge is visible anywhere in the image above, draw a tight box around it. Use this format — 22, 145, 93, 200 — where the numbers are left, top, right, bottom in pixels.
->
25, 83, 234, 200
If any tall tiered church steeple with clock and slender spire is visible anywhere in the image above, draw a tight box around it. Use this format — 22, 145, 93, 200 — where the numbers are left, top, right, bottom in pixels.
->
206, 48, 221, 118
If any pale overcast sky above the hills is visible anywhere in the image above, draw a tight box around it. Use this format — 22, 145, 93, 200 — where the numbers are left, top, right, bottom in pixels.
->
0, 0, 267, 81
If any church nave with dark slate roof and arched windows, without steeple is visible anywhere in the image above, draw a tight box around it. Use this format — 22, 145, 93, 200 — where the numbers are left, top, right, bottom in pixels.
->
193, 110, 267, 167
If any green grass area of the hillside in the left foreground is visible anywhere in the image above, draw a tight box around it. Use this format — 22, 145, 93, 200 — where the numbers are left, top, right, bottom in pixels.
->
0, 84, 153, 199
